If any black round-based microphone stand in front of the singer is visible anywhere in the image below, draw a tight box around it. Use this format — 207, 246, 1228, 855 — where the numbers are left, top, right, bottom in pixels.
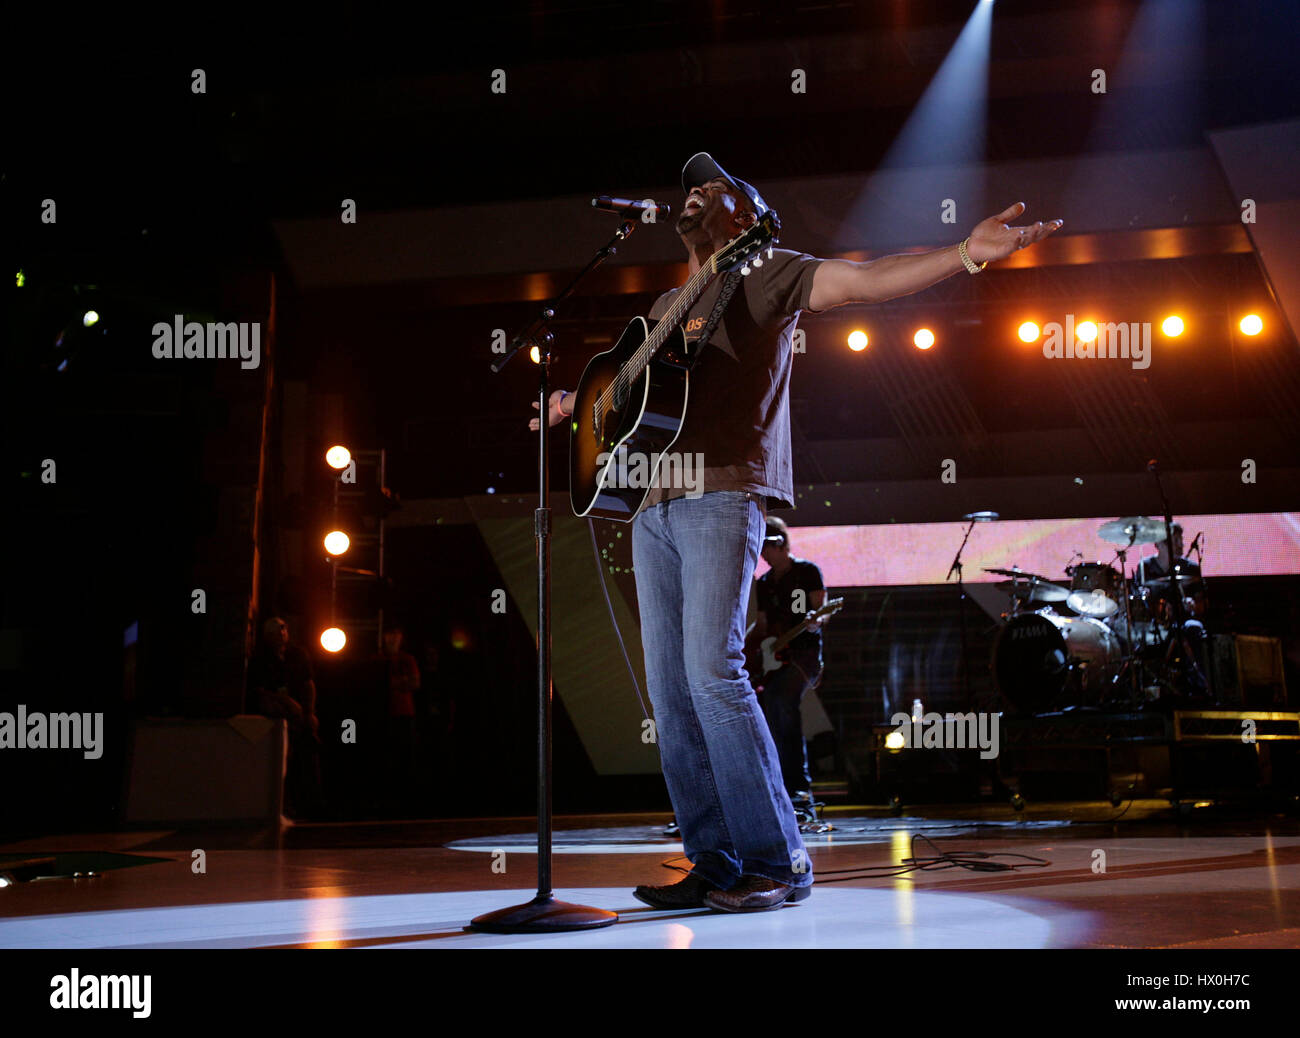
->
465, 219, 637, 934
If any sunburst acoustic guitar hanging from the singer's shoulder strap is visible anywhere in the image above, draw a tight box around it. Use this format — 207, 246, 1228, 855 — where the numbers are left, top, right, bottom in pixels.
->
569, 209, 781, 523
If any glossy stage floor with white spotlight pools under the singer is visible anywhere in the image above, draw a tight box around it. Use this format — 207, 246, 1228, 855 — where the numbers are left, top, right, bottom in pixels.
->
0, 805, 1300, 948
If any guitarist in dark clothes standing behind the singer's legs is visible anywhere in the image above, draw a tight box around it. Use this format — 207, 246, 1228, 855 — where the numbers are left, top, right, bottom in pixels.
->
749, 515, 826, 806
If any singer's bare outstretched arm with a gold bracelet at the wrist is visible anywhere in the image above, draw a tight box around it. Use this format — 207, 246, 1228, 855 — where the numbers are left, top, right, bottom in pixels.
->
809, 202, 1063, 310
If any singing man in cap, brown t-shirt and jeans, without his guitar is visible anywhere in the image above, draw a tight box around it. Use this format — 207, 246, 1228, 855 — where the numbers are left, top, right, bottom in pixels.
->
533, 152, 1060, 912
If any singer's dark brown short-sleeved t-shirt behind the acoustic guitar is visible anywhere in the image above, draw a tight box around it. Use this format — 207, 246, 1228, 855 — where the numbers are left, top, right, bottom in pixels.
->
645, 248, 822, 509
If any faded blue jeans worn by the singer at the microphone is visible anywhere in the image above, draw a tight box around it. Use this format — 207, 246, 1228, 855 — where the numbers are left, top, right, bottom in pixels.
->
632, 490, 813, 890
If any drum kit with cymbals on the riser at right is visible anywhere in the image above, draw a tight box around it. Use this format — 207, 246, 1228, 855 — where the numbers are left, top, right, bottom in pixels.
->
985, 515, 1208, 714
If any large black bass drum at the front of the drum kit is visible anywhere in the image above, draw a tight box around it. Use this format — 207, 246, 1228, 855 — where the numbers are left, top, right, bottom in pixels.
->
992, 609, 1122, 714
